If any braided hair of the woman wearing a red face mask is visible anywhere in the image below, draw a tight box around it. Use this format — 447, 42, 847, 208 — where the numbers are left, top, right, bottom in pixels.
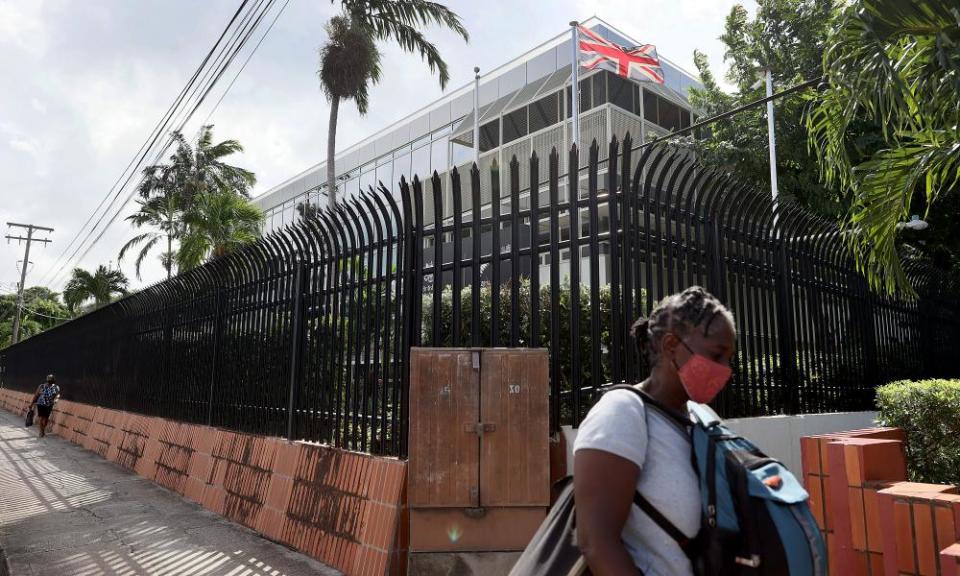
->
630, 286, 736, 367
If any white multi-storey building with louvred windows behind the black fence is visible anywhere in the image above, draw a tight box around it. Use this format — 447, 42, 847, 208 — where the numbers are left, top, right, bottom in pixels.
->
254, 17, 700, 238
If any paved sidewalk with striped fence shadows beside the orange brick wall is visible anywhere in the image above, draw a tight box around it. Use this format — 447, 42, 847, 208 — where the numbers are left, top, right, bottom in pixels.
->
0, 411, 339, 576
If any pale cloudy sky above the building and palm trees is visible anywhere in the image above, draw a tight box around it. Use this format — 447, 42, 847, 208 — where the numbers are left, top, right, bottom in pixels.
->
0, 0, 756, 294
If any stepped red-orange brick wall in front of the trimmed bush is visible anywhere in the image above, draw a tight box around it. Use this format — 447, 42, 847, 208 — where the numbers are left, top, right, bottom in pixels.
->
801, 428, 960, 576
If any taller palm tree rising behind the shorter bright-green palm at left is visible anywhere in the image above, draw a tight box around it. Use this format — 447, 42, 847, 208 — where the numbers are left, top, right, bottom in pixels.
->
119, 125, 257, 279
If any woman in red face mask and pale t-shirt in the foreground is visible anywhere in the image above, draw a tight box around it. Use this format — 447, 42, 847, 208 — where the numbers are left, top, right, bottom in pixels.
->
574, 287, 736, 576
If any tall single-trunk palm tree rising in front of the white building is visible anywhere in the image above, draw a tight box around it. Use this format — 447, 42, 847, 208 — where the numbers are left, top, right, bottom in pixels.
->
319, 0, 469, 209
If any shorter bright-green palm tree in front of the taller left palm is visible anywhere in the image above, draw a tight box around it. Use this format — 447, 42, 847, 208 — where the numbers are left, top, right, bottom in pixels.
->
177, 192, 263, 270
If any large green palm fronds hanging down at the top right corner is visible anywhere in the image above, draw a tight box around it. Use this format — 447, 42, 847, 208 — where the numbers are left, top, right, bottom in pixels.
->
806, 0, 960, 292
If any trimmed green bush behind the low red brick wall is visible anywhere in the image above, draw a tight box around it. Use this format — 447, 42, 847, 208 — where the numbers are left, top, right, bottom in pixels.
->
877, 380, 960, 485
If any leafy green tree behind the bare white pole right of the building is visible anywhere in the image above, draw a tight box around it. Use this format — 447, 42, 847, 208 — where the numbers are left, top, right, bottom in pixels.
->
686, 0, 842, 216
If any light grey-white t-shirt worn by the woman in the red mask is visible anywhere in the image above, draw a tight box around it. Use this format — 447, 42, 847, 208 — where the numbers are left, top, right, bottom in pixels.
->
573, 390, 700, 576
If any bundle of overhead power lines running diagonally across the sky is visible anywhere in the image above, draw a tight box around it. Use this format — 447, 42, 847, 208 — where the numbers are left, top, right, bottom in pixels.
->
38, 0, 273, 288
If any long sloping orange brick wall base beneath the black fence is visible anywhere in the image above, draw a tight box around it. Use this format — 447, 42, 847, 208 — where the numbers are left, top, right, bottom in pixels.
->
0, 389, 409, 576
